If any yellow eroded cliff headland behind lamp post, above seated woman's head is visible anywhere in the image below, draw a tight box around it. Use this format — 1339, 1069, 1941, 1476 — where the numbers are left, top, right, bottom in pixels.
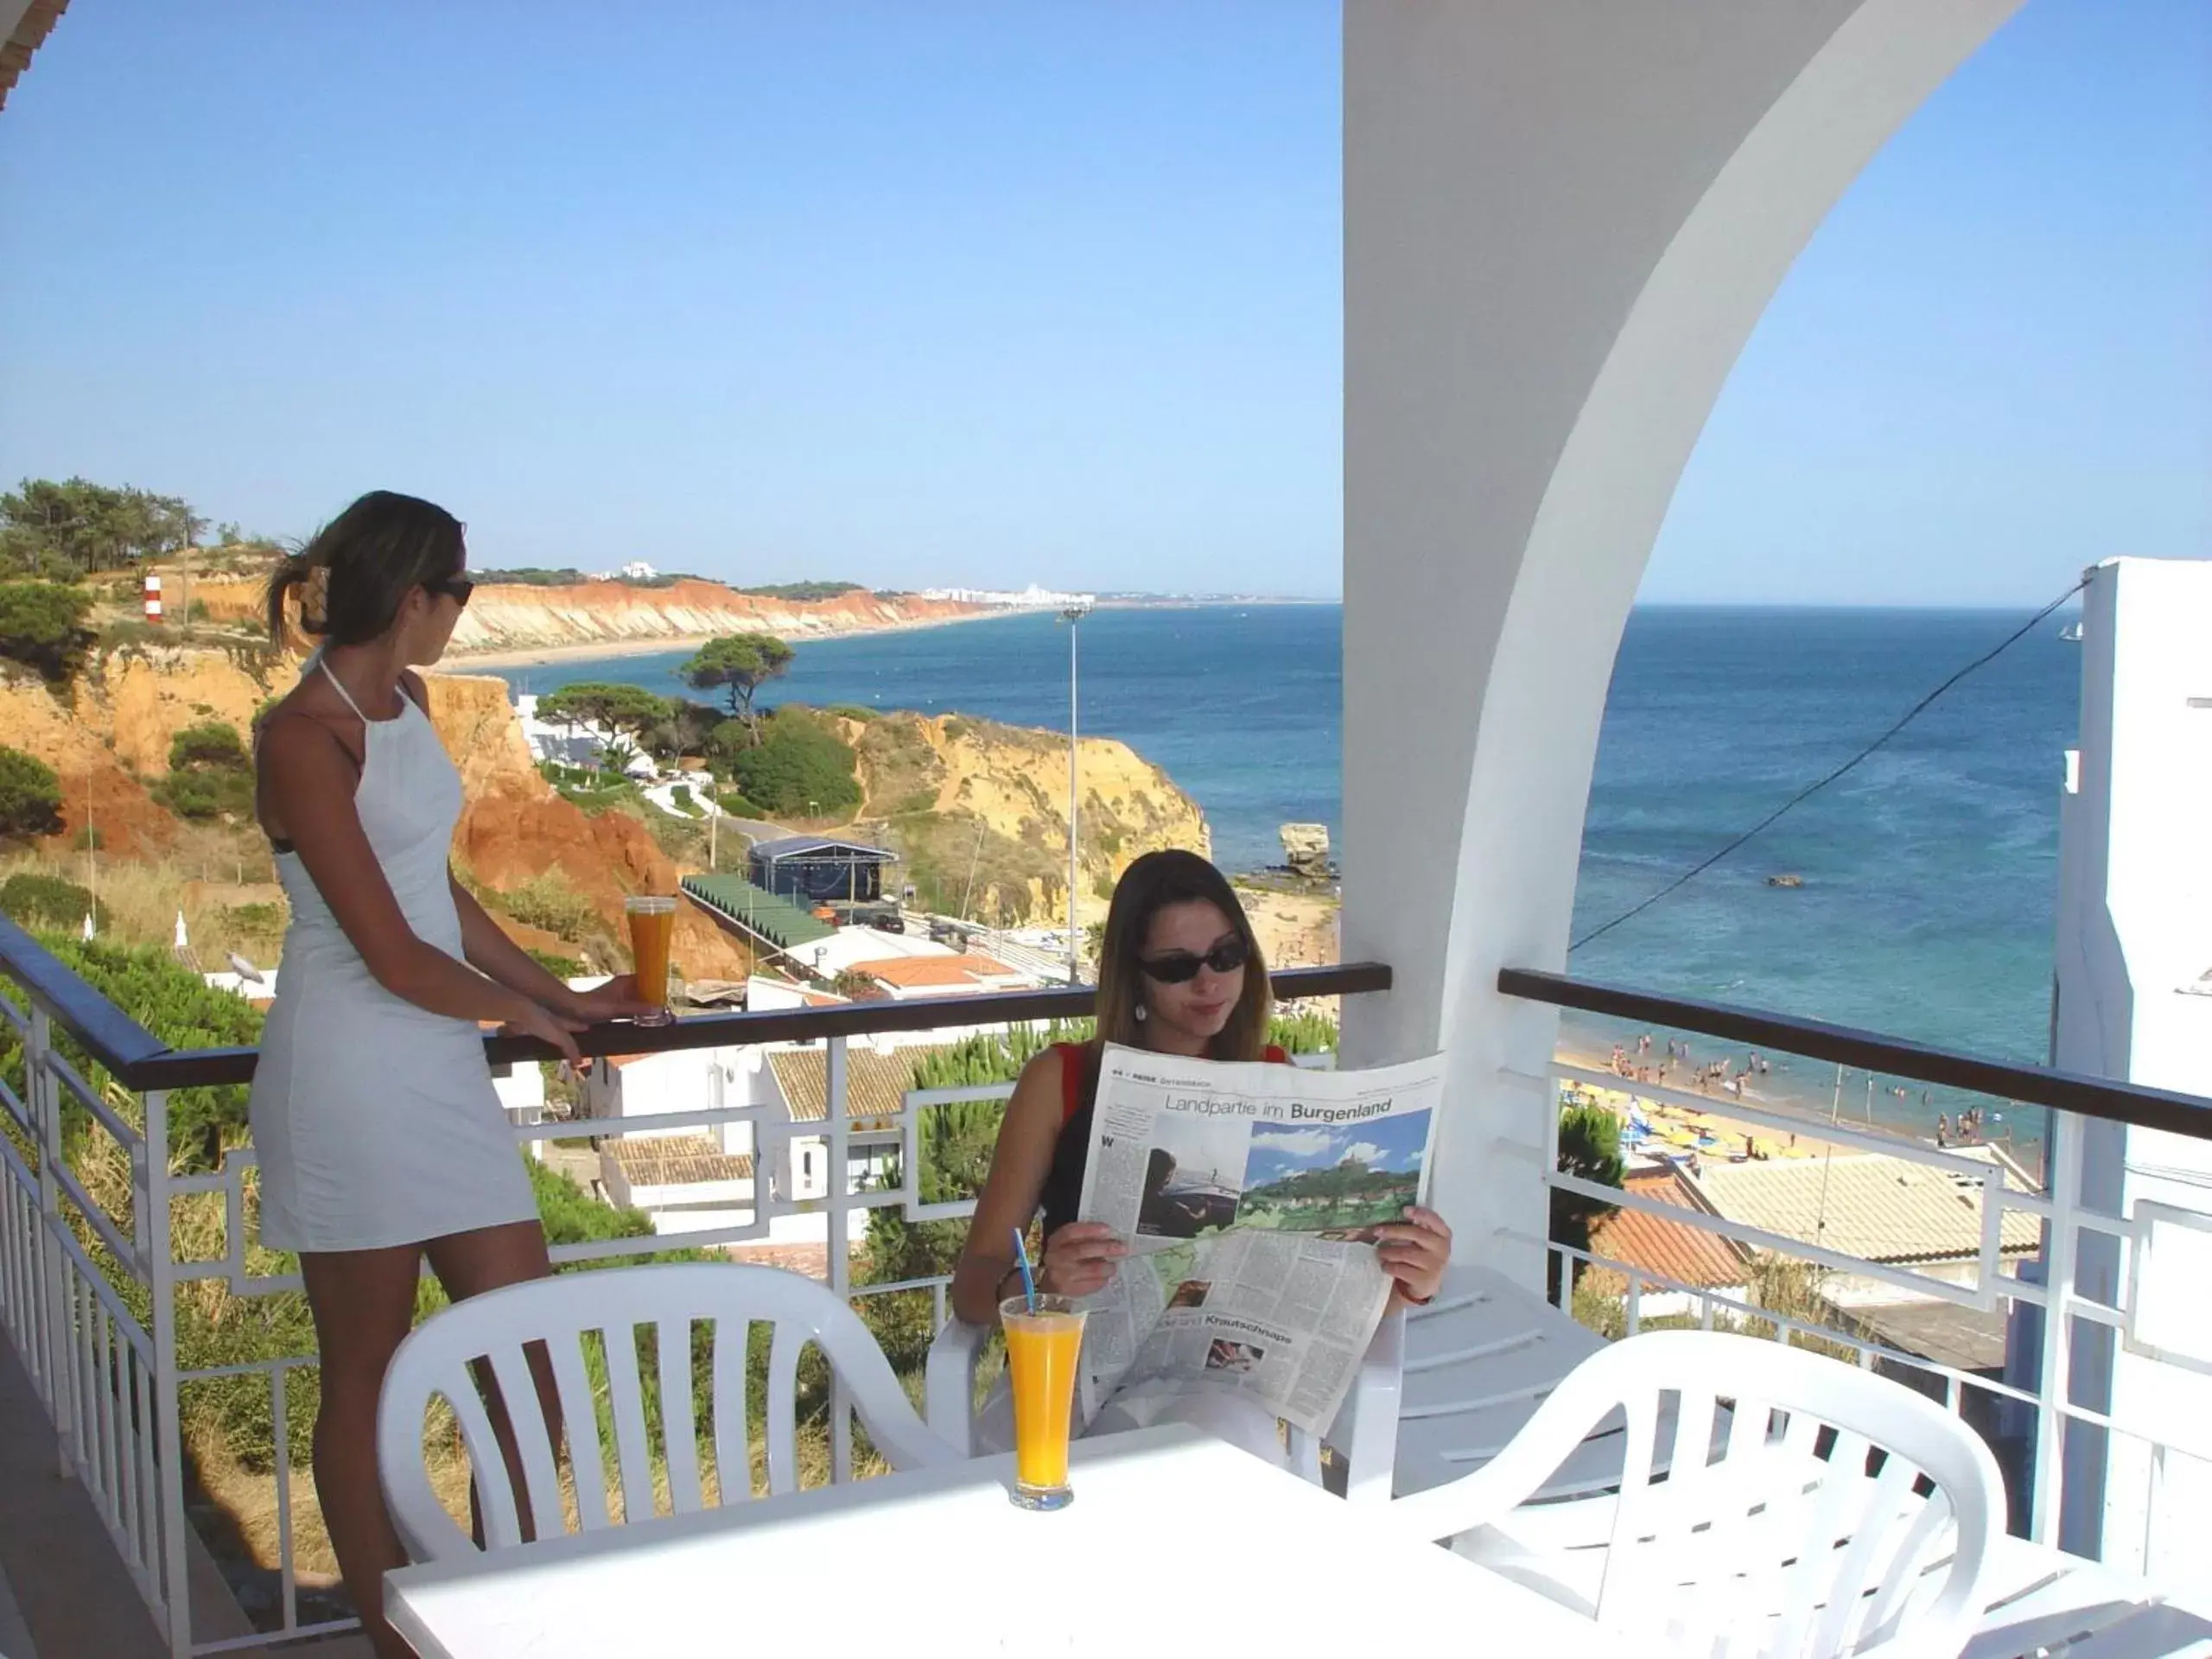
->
838, 715, 1212, 923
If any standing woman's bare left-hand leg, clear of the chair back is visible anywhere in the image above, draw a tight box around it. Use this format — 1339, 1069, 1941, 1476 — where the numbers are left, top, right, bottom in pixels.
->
299, 1245, 423, 1659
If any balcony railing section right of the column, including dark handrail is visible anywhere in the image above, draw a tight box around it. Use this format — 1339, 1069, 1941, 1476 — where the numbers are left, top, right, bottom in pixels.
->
1497, 969, 2212, 1566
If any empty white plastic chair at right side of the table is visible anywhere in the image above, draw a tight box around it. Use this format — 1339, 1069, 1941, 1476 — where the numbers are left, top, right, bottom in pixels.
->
1387, 1332, 2004, 1659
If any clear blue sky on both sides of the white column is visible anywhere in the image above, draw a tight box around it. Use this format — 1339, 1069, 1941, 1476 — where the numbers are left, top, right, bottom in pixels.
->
0, 0, 2212, 604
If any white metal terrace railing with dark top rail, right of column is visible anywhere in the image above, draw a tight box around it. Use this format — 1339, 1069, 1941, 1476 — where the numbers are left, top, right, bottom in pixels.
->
1497, 971, 2212, 1583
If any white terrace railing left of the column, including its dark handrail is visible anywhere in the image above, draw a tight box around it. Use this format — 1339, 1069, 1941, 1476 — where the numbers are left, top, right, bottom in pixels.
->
0, 920, 1389, 1659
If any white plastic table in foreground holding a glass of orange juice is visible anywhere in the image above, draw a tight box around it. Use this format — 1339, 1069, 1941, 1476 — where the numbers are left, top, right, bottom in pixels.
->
385, 1427, 1630, 1659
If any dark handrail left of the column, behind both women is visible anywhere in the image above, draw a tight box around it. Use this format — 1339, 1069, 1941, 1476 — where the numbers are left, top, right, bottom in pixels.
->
104, 969, 1389, 1090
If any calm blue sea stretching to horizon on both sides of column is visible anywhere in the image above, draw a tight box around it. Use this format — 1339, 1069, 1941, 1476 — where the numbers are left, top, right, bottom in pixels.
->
509, 606, 2079, 1084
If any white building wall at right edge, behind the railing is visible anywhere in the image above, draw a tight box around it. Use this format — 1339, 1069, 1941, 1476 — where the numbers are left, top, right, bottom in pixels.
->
2022, 560, 2212, 1580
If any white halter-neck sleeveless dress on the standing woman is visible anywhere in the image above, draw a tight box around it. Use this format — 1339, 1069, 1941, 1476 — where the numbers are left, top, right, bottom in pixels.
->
248, 657, 537, 1252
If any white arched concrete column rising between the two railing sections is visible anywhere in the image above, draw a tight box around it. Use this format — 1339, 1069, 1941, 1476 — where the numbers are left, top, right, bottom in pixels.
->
1343, 0, 2019, 1283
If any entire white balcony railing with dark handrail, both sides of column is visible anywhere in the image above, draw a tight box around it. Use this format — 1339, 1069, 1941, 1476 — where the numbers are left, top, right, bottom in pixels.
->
0, 920, 2212, 1656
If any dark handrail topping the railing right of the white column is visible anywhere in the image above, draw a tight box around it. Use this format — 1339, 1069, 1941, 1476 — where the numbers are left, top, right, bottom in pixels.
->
1497, 969, 2212, 1141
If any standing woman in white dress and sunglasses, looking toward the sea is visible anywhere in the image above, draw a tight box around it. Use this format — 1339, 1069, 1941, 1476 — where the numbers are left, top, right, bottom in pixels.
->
250, 491, 644, 1659
